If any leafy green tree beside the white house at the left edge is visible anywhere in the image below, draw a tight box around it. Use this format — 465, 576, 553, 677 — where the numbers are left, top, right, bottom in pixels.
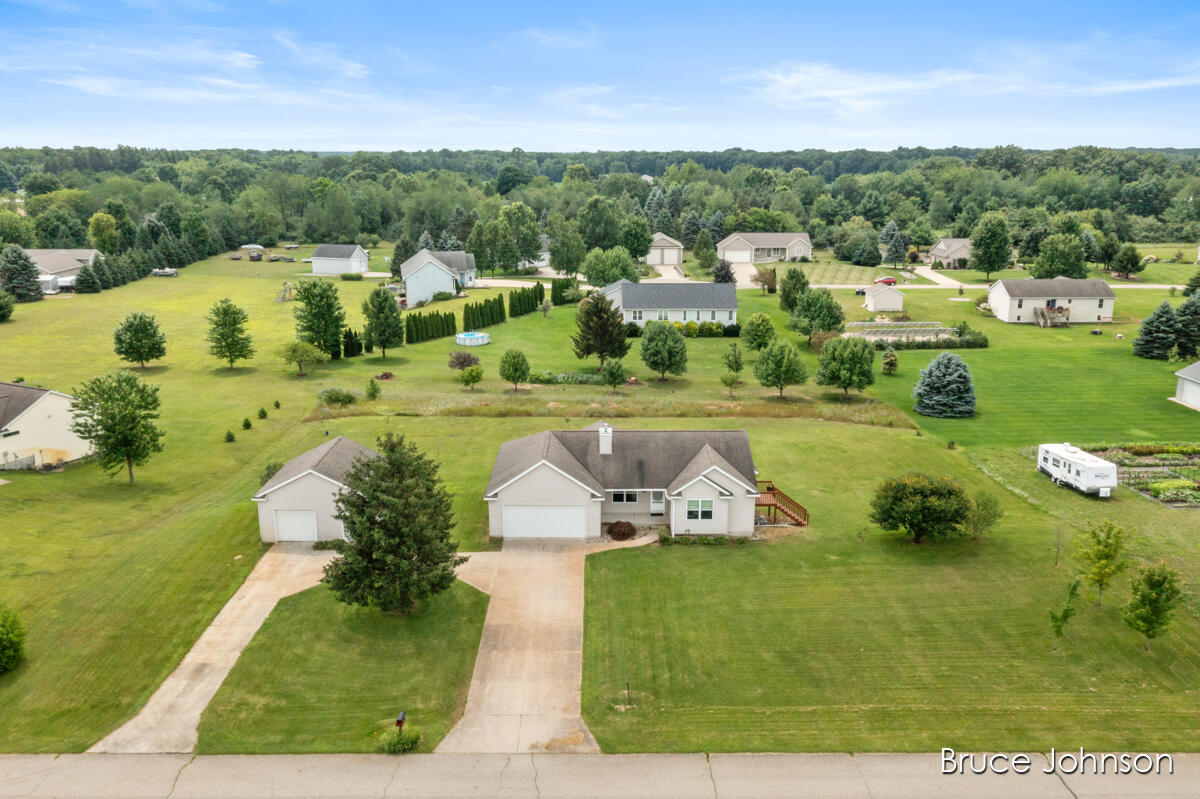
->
71, 372, 162, 482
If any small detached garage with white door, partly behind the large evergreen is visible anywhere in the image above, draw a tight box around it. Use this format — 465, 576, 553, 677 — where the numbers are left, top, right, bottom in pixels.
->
252, 435, 379, 543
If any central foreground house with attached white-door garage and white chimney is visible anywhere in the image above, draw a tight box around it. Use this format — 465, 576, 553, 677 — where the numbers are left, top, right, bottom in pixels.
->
484, 422, 758, 539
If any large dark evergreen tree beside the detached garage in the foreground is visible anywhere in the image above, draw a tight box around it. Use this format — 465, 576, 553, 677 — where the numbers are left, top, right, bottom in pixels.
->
322, 433, 467, 613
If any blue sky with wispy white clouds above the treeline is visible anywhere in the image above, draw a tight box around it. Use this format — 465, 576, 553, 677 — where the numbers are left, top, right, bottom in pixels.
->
0, 0, 1200, 150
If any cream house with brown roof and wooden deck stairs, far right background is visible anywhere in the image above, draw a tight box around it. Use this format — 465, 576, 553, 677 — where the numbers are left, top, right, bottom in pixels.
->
988, 277, 1117, 326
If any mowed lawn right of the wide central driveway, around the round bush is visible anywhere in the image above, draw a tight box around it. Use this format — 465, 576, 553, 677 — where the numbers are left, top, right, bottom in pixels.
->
583, 420, 1200, 752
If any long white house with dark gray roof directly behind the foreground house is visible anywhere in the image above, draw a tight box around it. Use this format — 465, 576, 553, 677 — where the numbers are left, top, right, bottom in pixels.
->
600, 280, 738, 326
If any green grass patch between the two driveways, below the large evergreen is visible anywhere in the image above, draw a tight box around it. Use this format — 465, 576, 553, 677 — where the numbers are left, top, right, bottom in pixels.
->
197, 575, 487, 753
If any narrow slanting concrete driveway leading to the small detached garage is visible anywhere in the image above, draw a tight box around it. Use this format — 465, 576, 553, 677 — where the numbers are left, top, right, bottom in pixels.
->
88, 543, 334, 753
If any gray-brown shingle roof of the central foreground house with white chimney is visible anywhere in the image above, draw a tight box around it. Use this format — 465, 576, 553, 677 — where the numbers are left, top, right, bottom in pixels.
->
485, 425, 755, 495
